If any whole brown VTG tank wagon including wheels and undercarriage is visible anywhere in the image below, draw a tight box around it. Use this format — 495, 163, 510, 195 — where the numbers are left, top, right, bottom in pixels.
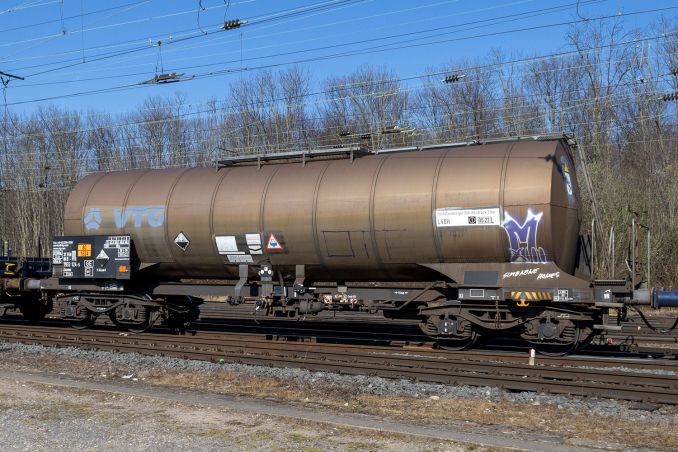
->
0, 135, 678, 353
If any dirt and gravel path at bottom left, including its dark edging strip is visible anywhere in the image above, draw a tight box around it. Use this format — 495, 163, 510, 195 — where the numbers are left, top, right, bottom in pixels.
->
0, 371, 592, 451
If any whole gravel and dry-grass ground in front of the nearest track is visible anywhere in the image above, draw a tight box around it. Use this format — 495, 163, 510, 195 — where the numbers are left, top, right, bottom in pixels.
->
0, 342, 678, 452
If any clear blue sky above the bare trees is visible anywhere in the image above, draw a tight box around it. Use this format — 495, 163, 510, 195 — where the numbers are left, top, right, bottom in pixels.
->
0, 0, 678, 113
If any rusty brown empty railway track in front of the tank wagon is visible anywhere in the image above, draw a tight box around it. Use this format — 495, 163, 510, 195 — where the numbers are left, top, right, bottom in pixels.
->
0, 325, 678, 405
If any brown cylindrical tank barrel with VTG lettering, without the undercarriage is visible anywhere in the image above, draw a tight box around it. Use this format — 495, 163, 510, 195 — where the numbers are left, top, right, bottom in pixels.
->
65, 140, 580, 281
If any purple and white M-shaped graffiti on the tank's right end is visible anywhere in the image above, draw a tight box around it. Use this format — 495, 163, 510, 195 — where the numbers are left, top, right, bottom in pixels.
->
503, 209, 548, 263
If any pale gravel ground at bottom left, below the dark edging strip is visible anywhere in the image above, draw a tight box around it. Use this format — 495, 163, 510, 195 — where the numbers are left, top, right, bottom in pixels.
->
0, 379, 464, 452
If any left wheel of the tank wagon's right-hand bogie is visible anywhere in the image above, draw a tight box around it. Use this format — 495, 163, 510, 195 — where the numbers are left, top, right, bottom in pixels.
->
420, 314, 480, 350
